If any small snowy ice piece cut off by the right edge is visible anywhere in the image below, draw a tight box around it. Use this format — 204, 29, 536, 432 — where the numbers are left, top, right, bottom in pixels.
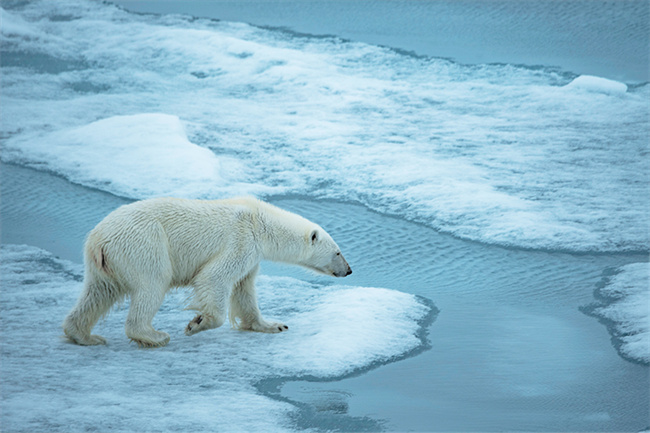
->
592, 262, 650, 364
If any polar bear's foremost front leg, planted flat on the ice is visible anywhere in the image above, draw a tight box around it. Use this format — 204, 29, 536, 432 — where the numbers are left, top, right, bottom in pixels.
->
229, 265, 289, 333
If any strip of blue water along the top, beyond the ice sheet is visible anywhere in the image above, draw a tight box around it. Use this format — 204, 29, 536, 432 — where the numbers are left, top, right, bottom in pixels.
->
112, 0, 650, 82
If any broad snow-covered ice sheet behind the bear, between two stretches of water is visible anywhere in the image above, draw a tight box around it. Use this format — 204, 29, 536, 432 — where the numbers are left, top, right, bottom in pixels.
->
1, 0, 650, 251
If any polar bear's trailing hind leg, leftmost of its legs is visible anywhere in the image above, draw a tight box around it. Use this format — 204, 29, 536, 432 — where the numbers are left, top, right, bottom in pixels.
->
63, 248, 124, 346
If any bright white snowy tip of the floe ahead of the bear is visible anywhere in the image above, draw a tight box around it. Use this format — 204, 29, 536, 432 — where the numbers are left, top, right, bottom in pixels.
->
262, 279, 427, 377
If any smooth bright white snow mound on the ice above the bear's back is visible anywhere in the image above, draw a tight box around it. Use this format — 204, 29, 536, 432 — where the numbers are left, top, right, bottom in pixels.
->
3, 113, 268, 198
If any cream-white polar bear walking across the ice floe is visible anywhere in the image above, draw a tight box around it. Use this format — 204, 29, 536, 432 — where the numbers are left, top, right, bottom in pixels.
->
63, 197, 352, 347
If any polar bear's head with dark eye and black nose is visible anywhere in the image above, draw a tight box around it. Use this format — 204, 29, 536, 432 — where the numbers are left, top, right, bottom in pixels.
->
300, 226, 352, 277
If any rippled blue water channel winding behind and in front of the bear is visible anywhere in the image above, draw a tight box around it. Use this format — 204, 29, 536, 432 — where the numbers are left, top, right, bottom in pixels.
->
2, 165, 650, 431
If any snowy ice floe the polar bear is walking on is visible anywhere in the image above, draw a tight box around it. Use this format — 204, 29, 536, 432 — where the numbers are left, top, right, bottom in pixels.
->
0, 245, 430, 432
